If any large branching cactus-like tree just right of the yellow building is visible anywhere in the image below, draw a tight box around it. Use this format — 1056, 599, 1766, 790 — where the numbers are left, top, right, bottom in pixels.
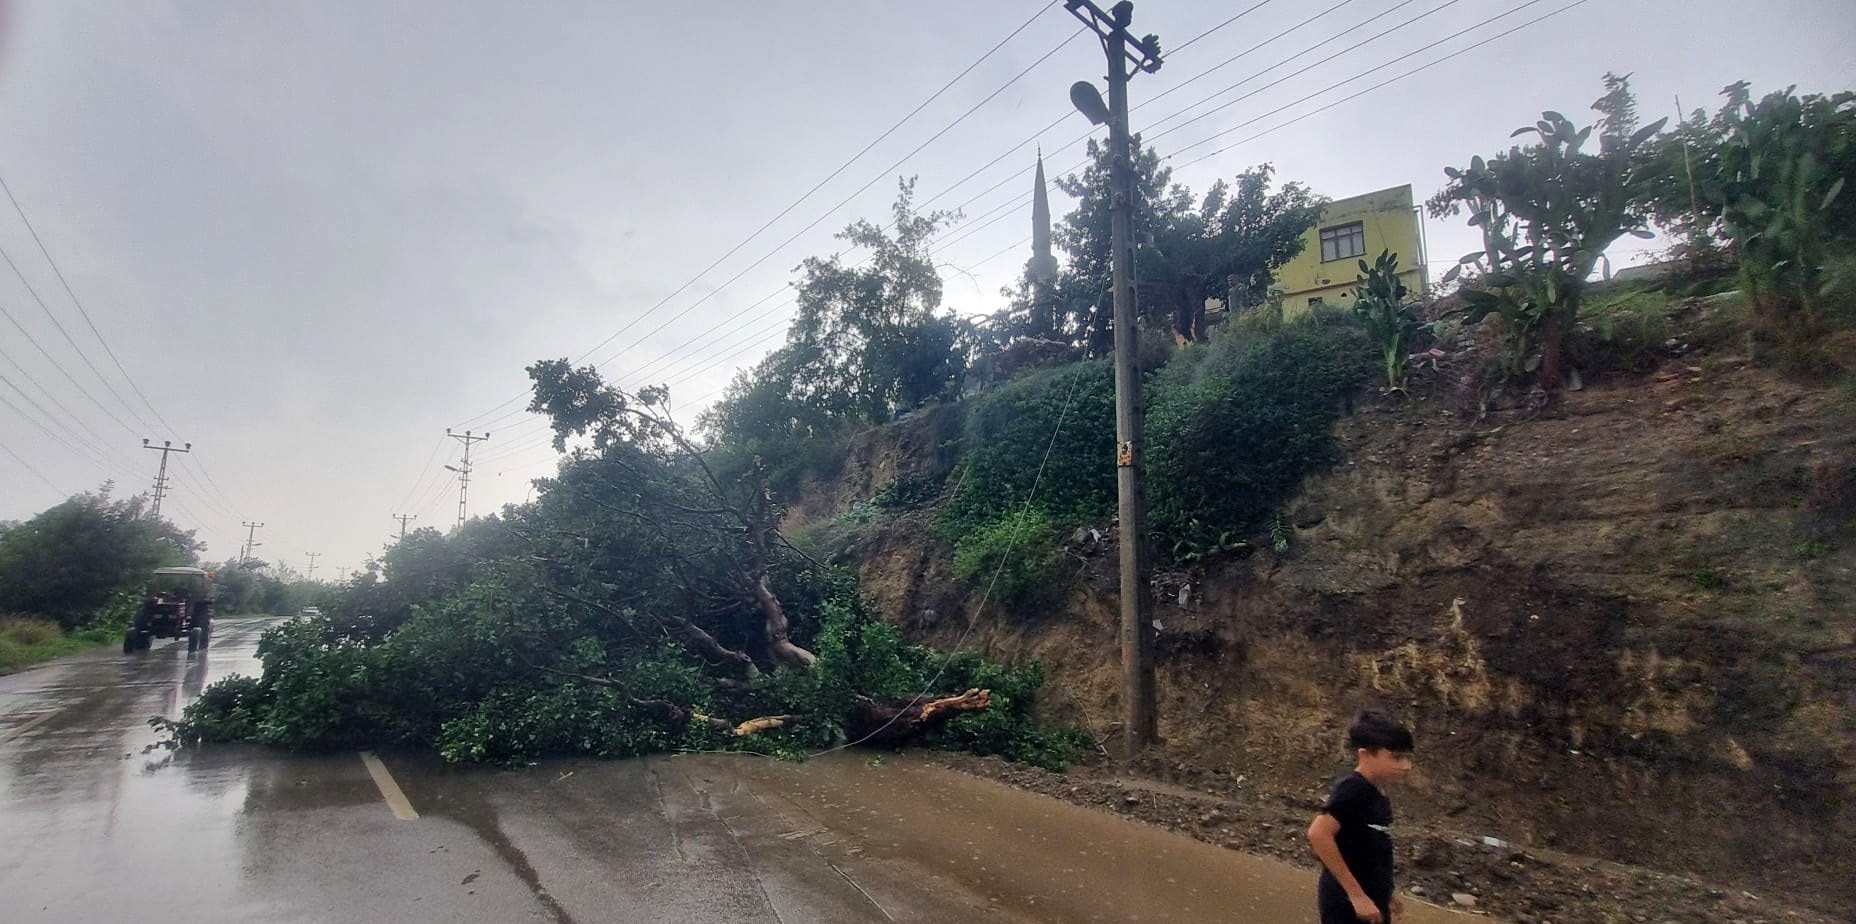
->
1427, 83, 1667, 388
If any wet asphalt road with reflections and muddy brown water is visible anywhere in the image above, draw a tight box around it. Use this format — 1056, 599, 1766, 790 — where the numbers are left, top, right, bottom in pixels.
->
0, 620, 1461, 924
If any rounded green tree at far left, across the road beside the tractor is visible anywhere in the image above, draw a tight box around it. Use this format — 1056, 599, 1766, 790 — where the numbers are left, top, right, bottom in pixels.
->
0, 484, 204, 629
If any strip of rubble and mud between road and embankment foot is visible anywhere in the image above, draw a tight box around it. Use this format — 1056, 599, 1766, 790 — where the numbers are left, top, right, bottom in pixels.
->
926, 753, 1845, 924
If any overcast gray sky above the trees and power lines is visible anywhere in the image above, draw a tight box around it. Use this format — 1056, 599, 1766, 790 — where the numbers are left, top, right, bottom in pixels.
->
0, 0, 1856, 575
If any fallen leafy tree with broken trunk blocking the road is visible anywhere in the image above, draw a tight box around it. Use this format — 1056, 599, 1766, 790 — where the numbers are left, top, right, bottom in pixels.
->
178, 362, 1067, 764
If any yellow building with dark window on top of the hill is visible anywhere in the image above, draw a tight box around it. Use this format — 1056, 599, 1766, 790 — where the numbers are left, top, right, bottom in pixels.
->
1275, 184, 1427, 317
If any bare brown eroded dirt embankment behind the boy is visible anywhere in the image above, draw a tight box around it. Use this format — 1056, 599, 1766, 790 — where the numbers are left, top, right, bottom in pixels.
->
796, 345, 1856, 920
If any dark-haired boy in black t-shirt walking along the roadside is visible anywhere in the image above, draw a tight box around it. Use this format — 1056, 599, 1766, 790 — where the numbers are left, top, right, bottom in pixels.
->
1308, 711, 1411, 924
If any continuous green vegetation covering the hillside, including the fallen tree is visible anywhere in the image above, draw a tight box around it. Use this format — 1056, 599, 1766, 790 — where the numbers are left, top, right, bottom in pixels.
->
163, 76, 1856, 766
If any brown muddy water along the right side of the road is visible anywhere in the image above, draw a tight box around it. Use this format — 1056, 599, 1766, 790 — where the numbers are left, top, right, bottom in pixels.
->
701, 753, 1463, 924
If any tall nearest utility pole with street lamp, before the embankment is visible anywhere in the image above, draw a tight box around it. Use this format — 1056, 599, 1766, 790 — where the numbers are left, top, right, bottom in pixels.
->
1063, 0, 1160, 757
